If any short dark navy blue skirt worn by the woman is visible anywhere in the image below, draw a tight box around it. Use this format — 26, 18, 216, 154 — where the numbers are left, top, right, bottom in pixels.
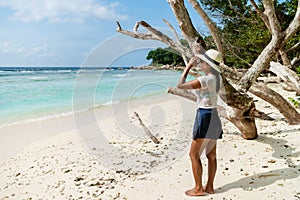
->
193, 108, 223, 140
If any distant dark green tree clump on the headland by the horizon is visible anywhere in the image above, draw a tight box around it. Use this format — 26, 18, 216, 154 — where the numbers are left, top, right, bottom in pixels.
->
146, 48, 184, 66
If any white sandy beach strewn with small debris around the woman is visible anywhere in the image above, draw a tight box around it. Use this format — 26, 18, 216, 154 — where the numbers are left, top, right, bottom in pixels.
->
0, 85, 300, 200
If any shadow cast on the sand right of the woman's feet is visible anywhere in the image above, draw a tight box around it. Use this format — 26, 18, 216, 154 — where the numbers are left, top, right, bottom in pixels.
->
216, 129, 300, 193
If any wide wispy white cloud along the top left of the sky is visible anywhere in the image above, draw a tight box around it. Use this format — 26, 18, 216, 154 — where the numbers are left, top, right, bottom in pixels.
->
0, 0, 128, 23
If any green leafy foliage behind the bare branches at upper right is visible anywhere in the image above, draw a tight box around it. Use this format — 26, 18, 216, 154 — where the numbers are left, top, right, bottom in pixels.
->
200, 0, 300, 68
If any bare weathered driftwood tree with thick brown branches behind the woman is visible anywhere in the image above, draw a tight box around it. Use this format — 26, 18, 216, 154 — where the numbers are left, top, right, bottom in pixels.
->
117, 0, 300, 139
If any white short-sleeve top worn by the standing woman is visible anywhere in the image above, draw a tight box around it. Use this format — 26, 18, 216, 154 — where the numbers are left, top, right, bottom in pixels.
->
195, 74, 218, 109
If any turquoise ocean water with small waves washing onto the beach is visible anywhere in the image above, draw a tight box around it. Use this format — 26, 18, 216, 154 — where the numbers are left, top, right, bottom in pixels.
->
0, 67, 180, 127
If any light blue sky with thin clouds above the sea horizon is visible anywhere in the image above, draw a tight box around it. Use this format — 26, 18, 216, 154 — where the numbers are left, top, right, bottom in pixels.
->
0, 0, 205, 66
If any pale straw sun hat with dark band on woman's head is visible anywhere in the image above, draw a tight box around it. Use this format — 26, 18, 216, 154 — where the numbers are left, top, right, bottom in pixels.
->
196, 49, 222, 73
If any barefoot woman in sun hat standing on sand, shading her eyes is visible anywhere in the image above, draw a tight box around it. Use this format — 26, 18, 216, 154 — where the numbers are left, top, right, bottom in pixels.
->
177, 45, 223, 196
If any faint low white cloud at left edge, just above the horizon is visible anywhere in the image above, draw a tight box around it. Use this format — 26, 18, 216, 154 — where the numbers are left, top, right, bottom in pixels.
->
0, 42, 53, 58
